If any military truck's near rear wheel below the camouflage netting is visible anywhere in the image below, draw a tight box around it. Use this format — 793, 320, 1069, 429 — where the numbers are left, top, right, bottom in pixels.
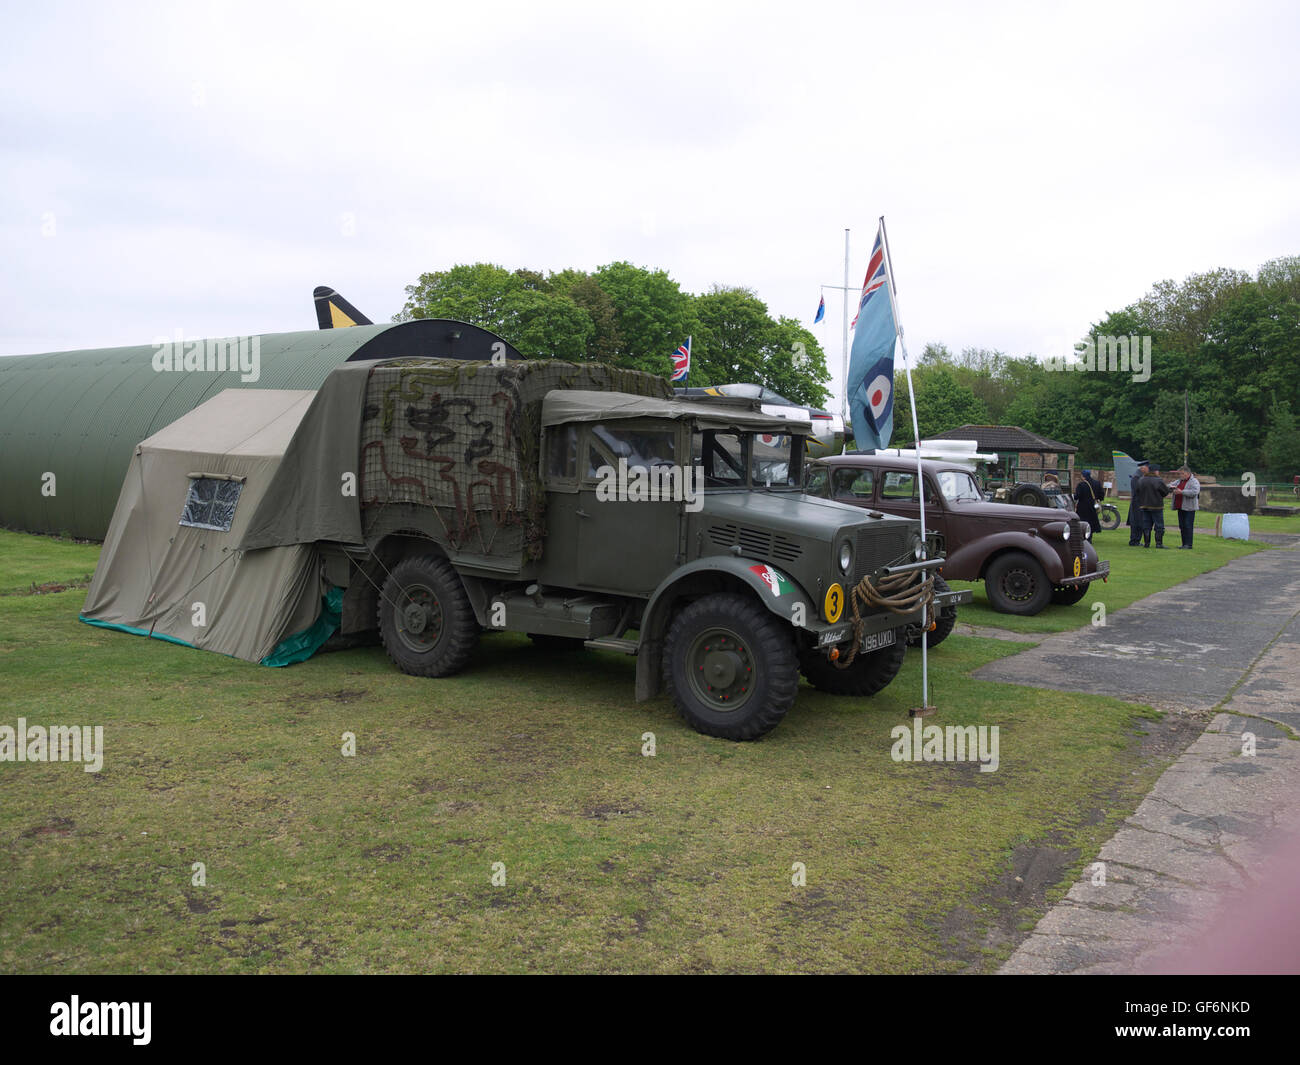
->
380, 555, 478, 676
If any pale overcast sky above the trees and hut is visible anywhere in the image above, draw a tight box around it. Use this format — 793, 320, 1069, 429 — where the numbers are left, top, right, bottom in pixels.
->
0, 0, 1300, 403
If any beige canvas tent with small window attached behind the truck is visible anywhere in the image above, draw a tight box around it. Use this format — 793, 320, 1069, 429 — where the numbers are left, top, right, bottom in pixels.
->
81, 389, 341, 666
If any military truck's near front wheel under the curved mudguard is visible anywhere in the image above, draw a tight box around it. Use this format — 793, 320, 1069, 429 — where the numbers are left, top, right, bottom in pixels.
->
663, 593, 800, 740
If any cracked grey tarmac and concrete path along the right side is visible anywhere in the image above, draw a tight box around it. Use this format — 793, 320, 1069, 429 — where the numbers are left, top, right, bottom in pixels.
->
975, 536, 1300, 974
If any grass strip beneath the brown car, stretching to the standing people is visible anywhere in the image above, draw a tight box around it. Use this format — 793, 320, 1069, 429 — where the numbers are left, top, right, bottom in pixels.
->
952, 516, 1268, 632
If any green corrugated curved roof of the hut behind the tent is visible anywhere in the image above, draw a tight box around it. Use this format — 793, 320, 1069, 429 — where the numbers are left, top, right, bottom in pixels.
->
0, 322, 408, 540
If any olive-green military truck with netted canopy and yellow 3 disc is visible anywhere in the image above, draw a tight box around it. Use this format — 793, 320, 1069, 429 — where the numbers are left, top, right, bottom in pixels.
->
246, 359, 970, 740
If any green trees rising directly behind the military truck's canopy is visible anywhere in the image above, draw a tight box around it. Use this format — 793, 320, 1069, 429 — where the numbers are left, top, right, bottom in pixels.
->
394, 263, 831, 407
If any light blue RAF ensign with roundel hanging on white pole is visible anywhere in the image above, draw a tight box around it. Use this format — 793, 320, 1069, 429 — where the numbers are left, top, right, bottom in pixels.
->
845, 222, 898, 451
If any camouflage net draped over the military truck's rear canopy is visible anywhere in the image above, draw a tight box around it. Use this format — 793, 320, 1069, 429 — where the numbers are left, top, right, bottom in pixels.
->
360, 359, 672, 560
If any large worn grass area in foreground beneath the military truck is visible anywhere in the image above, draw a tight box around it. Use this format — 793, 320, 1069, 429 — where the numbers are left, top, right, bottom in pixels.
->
0, 537, 1208, 973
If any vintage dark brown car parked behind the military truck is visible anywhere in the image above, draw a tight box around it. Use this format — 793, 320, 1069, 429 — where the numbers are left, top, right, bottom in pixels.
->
806, 454, 1110, 615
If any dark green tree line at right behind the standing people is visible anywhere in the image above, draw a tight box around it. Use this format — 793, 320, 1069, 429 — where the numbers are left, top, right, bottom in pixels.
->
894, 256, 1300, 479
